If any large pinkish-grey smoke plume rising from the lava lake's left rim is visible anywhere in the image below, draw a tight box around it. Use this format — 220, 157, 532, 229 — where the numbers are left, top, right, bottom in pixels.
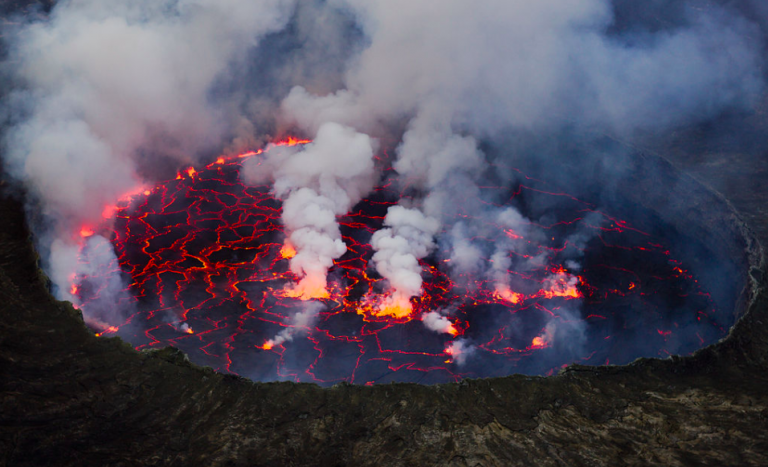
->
5, 0, 293, 326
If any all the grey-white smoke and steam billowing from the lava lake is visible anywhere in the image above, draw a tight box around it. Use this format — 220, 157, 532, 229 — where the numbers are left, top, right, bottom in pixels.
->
3, 0, 764, 378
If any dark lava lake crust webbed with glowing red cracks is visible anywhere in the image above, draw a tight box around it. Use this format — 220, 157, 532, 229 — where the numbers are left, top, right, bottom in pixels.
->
71, 140, 725, 384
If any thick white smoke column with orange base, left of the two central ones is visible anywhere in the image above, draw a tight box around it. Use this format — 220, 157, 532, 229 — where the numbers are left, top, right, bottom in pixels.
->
241, 123, 374, 298
